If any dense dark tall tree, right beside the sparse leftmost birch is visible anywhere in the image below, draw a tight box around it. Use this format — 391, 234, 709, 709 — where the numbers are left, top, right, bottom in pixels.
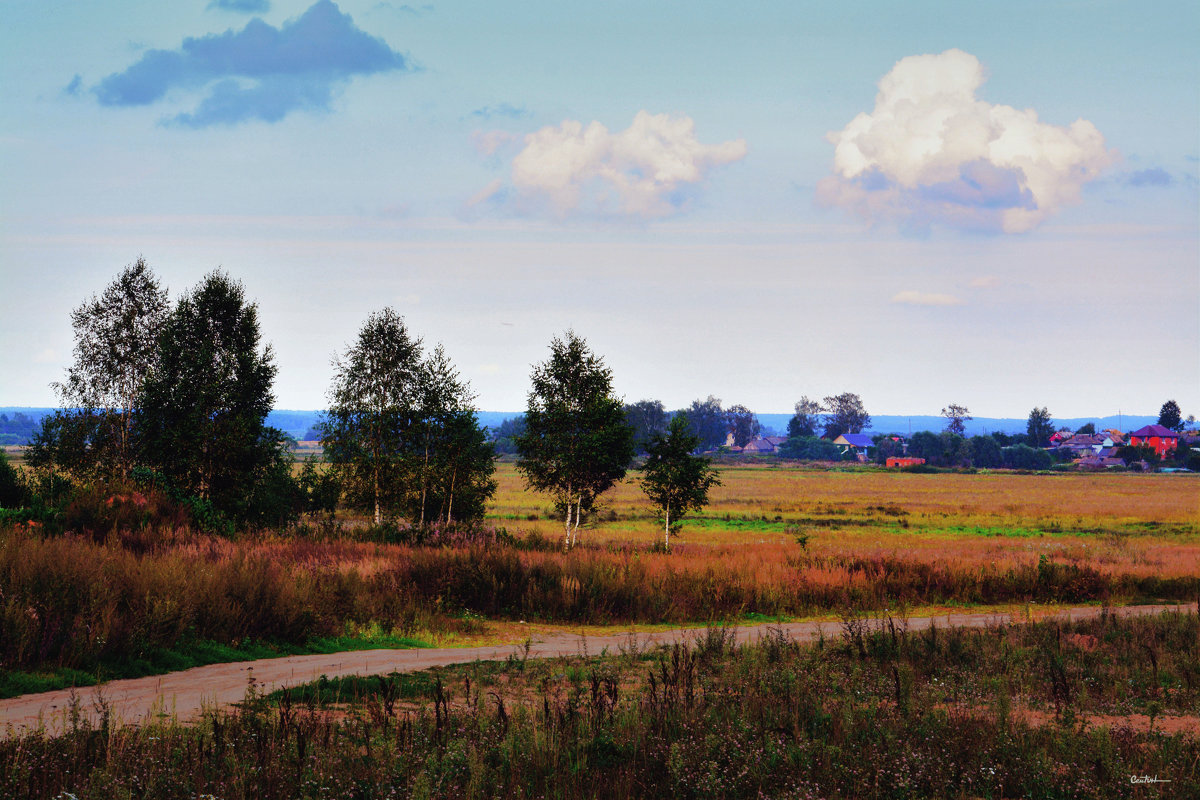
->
134, 271, 294, 522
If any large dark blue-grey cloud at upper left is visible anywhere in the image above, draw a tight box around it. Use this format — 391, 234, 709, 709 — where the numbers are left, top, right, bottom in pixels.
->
92, 0, 409, 127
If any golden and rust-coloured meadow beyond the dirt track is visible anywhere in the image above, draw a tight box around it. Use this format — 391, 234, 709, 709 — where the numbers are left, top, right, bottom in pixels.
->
0, 463, 1200, 694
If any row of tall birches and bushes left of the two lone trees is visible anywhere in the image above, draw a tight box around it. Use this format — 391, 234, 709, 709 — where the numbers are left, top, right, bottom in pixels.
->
18, 259, 496, 525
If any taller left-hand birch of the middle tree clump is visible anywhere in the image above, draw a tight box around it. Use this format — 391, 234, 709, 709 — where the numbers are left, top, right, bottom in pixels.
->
322, 307, 421, 525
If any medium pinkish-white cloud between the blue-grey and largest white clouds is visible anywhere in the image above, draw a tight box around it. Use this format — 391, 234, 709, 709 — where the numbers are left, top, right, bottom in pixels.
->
494, 110, 746, 218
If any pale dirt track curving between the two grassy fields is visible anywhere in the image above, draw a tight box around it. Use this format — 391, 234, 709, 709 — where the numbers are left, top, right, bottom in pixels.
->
0, 604, 1180, 736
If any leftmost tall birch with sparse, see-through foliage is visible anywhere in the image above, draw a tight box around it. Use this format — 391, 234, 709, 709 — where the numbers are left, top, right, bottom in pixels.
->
30, 258, 169, 479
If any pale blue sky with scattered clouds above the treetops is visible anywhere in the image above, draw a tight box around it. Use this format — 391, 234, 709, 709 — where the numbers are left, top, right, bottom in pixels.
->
0, 0, 1200, 417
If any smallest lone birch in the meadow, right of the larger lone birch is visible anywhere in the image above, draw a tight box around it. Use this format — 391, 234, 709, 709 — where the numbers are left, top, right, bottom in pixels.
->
642, 416, 720, 548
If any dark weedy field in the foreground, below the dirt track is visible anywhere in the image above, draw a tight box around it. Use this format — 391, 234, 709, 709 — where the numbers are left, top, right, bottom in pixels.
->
0, 612, 1200, 800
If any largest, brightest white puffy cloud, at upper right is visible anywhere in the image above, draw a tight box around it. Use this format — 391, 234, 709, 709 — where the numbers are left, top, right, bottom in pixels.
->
817, 49, 1117, 233
